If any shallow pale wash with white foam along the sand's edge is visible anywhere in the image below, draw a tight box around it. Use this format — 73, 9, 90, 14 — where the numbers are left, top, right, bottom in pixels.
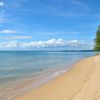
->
1, 63, 71, 100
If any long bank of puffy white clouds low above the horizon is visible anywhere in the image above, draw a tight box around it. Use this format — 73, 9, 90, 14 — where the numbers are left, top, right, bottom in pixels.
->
0, 39, 93, 49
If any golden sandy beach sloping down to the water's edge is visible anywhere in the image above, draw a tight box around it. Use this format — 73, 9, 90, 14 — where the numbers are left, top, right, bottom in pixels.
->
13, 55, 100, 100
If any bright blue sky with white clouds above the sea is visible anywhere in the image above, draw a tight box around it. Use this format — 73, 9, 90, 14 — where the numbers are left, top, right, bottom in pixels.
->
0, 0, 100, 50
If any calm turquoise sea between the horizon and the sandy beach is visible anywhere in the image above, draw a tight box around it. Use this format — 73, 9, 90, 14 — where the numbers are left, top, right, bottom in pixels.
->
0, 51, 99, 100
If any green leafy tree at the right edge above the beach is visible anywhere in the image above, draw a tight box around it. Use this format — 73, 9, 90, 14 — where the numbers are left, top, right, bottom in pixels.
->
94, 26, 100, 51
